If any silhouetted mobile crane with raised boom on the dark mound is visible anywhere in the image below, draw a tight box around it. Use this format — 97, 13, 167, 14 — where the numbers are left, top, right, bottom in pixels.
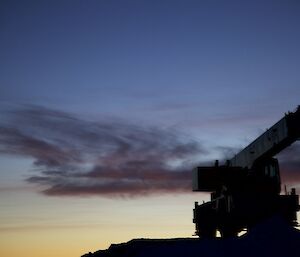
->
193, 106, 300, 237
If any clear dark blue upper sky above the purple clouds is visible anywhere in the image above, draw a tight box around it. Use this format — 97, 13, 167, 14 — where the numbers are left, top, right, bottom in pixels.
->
0, 1, 300, 119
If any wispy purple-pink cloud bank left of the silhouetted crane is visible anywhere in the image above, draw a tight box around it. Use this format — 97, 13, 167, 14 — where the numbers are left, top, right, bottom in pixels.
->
0, 106, 206, 197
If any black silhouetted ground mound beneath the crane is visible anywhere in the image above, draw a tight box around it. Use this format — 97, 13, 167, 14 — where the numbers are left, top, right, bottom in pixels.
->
82, 217, 300, 257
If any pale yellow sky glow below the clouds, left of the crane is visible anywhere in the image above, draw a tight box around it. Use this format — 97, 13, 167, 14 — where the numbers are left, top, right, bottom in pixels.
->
0, 189, 209, 257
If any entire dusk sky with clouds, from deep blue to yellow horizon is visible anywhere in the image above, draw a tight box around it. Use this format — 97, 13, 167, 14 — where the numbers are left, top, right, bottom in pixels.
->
0, 0, 300, 257
